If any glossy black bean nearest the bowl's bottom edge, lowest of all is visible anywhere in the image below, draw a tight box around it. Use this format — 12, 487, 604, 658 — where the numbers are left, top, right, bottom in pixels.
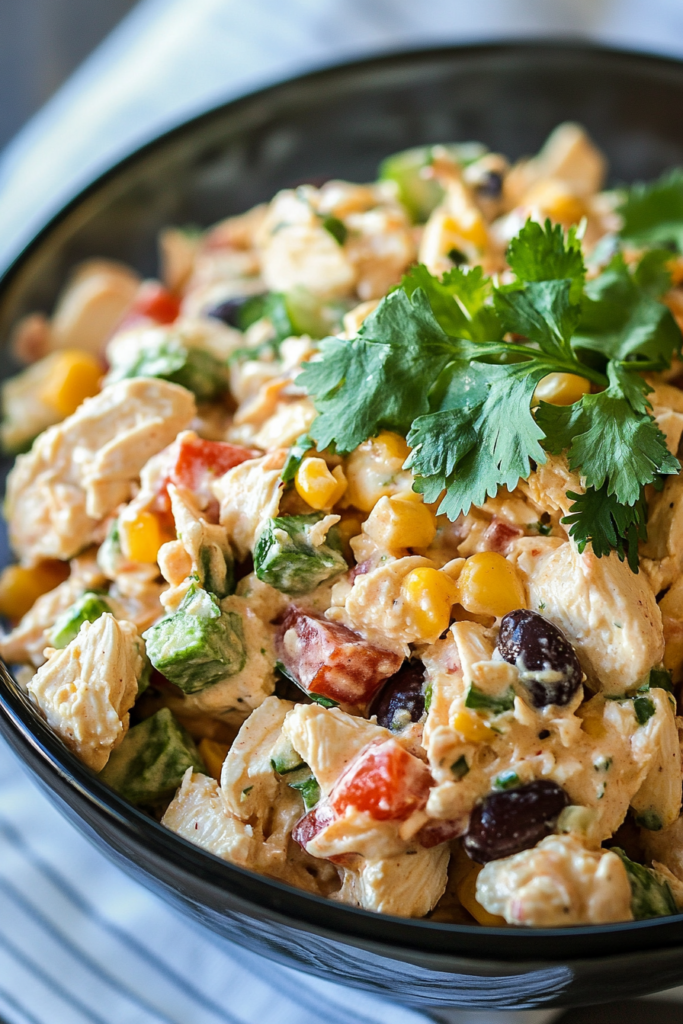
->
464, 779, 569, 864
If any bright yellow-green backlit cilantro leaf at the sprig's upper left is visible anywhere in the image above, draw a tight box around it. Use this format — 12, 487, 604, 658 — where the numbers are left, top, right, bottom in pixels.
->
400, 263, 504, 341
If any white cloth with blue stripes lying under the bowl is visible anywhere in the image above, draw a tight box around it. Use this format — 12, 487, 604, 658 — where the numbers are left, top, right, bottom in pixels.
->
0, 0, 683, 1024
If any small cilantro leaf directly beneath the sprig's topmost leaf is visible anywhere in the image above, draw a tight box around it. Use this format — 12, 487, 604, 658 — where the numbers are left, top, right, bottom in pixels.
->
494, 281, 581, 361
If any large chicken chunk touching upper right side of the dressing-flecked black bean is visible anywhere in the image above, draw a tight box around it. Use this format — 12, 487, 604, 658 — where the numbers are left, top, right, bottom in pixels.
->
528, 544, 664, 694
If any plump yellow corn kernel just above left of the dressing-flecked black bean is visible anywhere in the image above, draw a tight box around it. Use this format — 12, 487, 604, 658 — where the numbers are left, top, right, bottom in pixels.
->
458, 551, 526, 618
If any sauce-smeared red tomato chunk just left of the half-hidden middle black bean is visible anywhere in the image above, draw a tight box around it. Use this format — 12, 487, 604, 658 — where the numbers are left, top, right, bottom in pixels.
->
276, 605, 402, 706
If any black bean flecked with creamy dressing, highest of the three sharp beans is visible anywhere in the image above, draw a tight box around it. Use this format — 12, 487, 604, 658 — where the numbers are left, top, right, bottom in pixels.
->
498, 608, 583, 708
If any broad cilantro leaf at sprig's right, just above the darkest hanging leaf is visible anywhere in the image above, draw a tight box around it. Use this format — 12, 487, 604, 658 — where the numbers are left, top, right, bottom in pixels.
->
537, 362, 680, 506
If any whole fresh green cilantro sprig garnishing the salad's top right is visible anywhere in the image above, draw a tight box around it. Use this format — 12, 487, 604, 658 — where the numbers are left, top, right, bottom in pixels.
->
297, 220, 683, 571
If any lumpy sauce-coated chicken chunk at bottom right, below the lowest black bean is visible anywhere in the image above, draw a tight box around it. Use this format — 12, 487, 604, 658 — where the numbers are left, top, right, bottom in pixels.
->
476, 836, 633, 928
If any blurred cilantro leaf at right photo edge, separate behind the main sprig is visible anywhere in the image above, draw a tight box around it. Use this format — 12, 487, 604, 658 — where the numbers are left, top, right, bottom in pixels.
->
616, 168, 683, 252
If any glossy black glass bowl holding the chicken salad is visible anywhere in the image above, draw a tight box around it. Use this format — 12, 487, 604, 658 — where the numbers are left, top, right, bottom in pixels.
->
0, 43, 683, 1009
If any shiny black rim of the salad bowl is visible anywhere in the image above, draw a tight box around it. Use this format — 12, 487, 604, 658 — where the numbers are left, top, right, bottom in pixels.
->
0, 38, 683, 964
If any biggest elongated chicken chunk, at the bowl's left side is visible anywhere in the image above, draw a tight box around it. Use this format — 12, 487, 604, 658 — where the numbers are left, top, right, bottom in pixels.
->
6, 379, 195, 564
